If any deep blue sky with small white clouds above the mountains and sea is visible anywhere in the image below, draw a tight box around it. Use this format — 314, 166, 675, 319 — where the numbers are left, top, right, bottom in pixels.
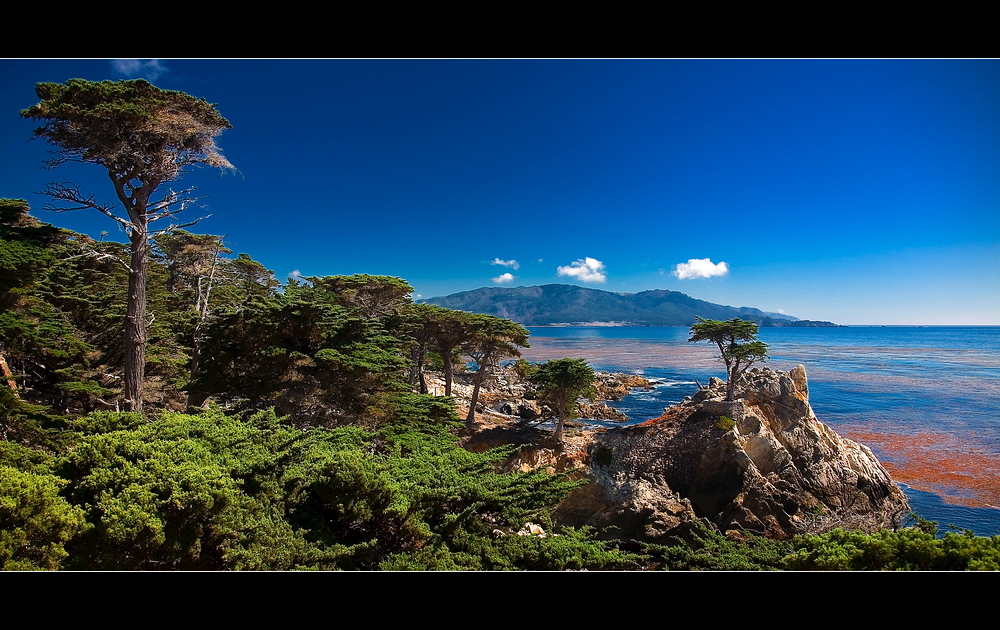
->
0, 59, 1000, 325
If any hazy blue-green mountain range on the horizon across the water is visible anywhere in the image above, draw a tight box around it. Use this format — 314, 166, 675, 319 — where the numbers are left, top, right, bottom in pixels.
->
422, 284, 836, 327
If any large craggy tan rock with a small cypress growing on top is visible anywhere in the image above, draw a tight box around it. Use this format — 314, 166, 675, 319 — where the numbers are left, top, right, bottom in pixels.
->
556, 366, 909, 541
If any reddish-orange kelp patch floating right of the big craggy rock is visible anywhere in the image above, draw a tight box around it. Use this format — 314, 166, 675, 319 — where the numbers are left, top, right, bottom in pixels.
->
844, 427, 1000, 508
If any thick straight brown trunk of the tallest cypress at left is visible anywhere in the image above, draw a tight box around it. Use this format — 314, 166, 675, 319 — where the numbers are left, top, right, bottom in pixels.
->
125, 227, 149, 412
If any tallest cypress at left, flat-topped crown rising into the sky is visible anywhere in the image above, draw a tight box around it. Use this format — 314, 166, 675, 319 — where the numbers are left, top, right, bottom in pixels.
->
21, 79, 232, 411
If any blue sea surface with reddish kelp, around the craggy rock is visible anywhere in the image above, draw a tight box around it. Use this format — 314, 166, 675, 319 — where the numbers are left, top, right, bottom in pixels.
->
523, 326, 1000, 536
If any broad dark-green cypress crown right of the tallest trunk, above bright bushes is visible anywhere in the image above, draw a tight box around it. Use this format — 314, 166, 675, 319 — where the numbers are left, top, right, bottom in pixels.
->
191, 281, 407, 424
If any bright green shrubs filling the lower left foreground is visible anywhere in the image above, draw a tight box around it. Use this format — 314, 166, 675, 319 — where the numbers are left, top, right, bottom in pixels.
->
0, 394, 612, 570
